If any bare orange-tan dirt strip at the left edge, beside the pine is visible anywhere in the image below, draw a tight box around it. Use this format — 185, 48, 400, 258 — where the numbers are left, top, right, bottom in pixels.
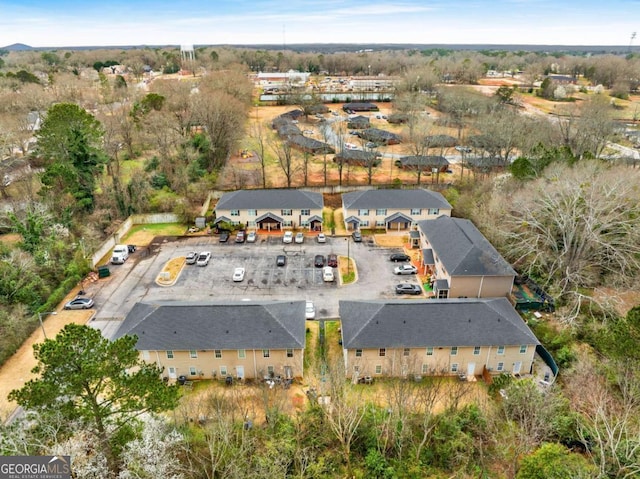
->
0, 287, 94, 421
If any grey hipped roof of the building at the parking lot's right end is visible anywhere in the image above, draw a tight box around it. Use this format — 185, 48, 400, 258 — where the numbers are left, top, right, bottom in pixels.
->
418, 215, 516, 276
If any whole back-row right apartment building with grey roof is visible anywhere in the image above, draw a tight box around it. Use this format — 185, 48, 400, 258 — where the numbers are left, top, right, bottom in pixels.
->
342, 188, 452, 231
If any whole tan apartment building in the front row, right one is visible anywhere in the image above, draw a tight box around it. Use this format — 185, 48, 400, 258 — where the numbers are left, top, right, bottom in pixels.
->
340, 298, 540, 380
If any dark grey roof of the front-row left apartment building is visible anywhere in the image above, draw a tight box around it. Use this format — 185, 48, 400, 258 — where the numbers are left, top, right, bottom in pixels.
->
115, 301, 305, 351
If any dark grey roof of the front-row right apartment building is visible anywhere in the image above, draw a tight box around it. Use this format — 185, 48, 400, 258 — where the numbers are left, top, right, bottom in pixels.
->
340, 298, 540, 349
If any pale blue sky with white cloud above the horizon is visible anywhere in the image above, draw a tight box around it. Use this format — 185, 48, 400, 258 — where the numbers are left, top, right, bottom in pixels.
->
0, 0, 640, 47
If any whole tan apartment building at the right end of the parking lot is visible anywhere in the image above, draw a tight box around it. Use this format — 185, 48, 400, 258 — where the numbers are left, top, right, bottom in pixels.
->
413, 216, 516, 298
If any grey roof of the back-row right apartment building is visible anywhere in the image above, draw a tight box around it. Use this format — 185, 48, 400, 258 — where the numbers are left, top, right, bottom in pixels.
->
342, 188, 451, 210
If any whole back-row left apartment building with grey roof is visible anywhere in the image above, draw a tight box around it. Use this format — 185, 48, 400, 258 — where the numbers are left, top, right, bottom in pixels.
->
214, 189, 324, 231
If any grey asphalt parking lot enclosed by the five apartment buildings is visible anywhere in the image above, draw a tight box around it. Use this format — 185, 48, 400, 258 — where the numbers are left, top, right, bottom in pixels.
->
89, 235, 417, 336
